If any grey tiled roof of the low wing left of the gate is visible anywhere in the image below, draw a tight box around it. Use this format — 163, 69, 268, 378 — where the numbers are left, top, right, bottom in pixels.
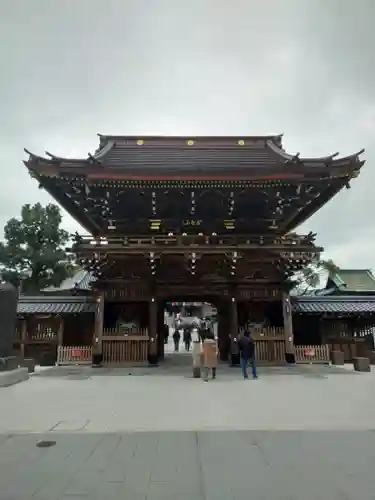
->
17, 295, 95, 314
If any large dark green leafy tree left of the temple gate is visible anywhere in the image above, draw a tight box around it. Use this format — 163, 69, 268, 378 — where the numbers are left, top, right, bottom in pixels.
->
0, 203, 74, 292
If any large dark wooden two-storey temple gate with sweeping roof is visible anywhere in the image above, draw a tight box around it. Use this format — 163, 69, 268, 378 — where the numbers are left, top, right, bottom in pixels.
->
26, 136, 364, 364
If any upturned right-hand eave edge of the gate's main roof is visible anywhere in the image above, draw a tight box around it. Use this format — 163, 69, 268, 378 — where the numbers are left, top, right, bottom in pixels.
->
267, 141, 365, 169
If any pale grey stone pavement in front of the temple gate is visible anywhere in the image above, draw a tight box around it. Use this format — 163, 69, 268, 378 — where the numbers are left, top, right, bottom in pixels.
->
0, 367, 375, 500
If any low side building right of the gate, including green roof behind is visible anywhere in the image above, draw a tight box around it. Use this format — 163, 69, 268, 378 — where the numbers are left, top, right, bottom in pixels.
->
292, 269, 375, 361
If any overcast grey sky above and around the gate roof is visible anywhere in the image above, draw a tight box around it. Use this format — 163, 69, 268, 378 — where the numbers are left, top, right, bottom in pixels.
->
0, 0, 375, 268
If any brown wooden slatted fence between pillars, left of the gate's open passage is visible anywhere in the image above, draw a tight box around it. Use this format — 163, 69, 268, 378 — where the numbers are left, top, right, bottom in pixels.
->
103, 329, 149, 365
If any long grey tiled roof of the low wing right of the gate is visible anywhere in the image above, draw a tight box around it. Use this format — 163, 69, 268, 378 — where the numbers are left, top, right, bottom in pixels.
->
292, 295, 375, 313
